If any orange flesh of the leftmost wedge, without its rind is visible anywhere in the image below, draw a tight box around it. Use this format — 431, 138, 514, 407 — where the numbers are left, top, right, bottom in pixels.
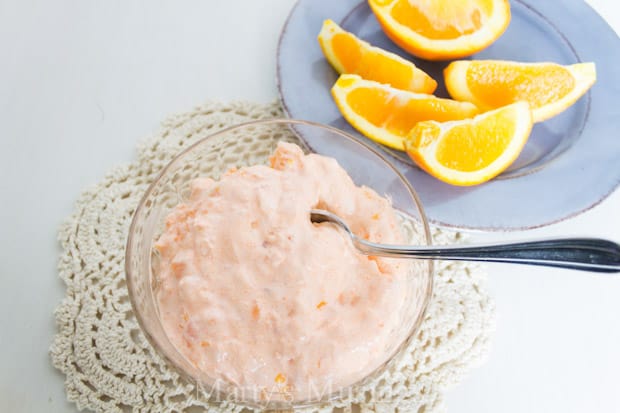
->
332, 33, 414, 90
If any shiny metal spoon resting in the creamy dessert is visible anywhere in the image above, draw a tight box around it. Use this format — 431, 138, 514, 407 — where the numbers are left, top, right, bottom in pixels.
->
310, 209, 620, 272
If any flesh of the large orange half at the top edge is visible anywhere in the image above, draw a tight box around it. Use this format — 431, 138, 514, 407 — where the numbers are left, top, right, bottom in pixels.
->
388, 0, 493, 40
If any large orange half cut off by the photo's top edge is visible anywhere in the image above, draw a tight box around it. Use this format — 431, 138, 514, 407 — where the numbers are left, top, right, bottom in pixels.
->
368, 0, 510, 60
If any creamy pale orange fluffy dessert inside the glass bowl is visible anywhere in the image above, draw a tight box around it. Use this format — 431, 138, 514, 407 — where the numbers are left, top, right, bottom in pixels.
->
156, 143, 409, 397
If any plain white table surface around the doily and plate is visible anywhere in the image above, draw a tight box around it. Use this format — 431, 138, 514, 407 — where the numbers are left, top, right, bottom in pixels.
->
0, 0, 620, 412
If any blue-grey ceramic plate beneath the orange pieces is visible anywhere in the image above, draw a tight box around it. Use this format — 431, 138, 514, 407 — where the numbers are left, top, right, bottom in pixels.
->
277, 0, 620, 230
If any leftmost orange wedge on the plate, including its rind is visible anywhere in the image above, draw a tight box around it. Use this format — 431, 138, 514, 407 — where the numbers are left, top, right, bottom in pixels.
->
318, 20, 437, 93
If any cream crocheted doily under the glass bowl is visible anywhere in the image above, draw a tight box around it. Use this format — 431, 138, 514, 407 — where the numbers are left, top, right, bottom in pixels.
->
50, 102, 494, 412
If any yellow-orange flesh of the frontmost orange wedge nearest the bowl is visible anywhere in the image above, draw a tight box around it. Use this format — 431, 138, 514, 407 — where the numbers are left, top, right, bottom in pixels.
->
436, 109, 517, 172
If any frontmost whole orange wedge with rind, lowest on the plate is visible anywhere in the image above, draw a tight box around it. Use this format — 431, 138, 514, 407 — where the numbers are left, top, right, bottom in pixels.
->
405, 102, 533, 186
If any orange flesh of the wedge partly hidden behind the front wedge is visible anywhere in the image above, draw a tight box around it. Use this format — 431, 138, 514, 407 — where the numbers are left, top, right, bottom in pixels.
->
347, 87, 477, 136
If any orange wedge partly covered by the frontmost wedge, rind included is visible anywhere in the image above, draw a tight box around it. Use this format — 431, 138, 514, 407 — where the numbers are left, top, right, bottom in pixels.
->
332, 74, 478, 151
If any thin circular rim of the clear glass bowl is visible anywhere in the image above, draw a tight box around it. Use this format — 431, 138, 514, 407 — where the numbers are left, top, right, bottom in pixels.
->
124, 118, 434, 410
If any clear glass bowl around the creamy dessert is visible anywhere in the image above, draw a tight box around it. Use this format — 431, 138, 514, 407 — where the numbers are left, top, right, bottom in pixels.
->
125, 119, 433, 410
